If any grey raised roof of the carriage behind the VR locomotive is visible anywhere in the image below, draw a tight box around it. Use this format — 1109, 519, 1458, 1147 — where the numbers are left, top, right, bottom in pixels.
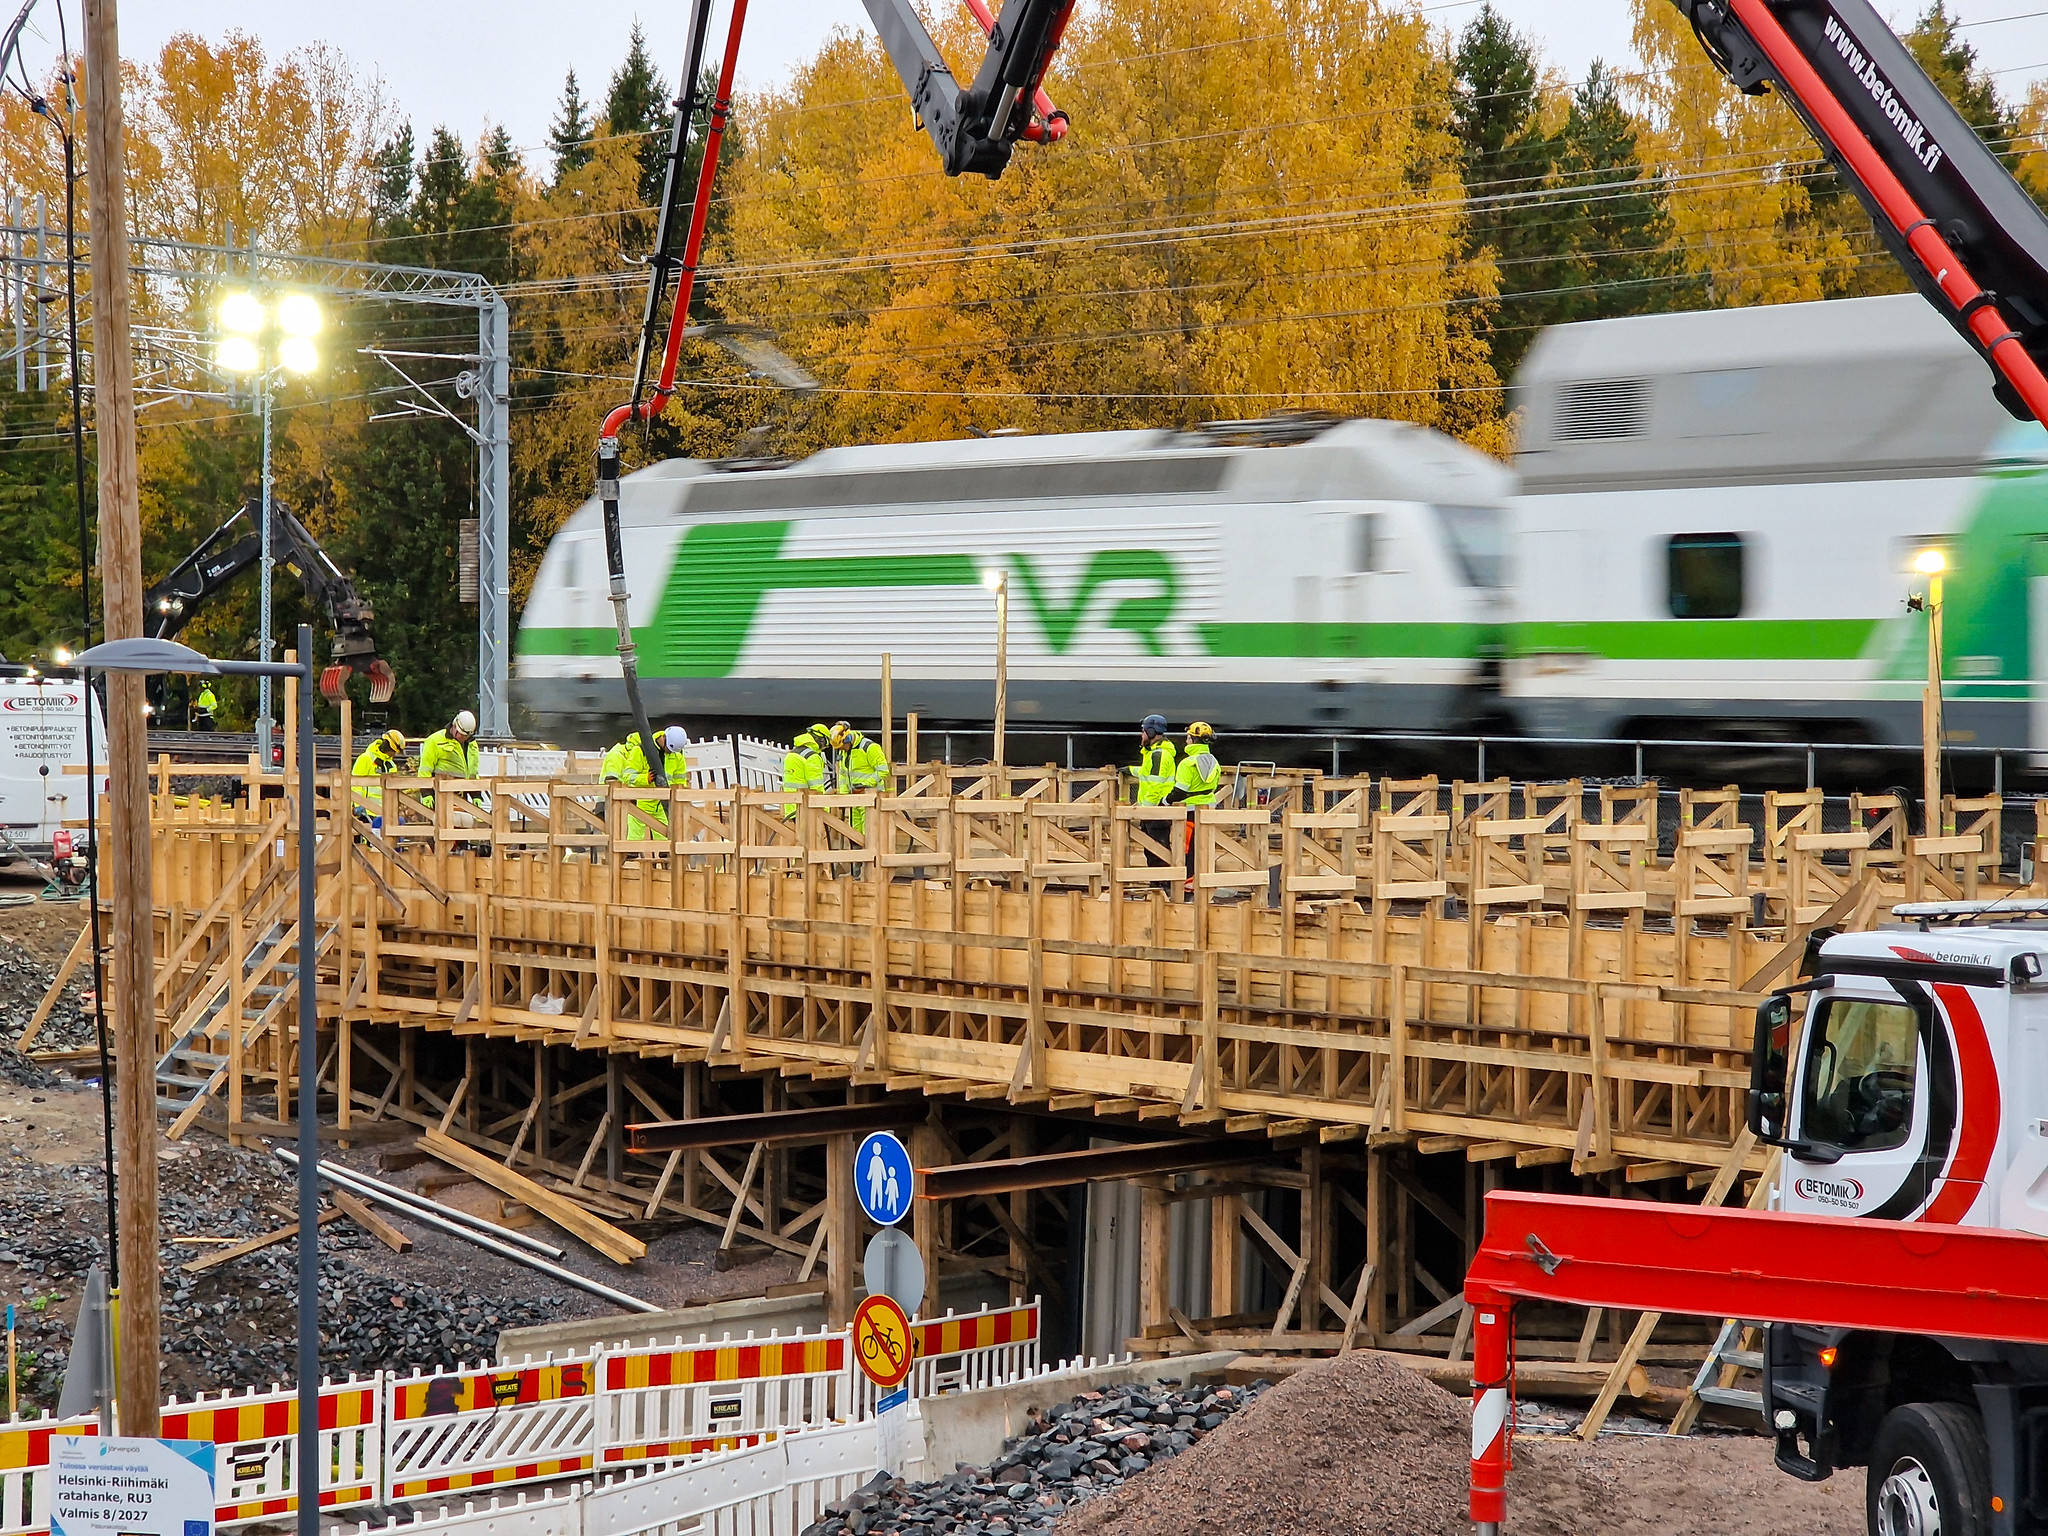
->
1511, 293, 2011, 494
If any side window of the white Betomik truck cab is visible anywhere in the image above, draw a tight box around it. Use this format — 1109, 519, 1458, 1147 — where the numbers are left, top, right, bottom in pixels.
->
1798, 997, 1921, 1151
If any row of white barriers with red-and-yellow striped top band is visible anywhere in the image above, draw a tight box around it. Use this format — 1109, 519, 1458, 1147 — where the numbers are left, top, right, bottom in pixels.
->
0, 1303, 1038, 1536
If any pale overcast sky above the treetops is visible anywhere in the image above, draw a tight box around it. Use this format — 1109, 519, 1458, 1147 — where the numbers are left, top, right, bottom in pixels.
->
12, 0, 2048, 168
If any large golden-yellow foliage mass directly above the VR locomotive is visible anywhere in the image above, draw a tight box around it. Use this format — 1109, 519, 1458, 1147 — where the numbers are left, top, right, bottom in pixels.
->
711, 0, 1503, 449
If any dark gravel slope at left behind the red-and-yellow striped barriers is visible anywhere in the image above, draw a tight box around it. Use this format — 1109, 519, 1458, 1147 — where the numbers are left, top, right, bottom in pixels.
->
0, 903, 797, 1411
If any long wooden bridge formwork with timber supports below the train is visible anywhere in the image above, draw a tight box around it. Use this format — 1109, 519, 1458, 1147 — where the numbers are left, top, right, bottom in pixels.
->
92, 741, 2042, 1348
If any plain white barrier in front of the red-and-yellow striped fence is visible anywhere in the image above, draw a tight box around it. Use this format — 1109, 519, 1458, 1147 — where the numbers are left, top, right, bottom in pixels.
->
356, 1421, 881, 1536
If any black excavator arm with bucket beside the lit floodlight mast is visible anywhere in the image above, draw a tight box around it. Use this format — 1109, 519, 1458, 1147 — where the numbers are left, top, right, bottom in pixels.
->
143, 498, 397, 705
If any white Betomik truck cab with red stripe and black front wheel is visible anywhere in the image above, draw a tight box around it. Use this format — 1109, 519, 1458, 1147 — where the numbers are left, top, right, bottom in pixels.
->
1749, 897, 2048, 1536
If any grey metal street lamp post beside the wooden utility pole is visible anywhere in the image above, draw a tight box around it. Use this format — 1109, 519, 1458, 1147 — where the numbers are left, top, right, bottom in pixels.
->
76, 625, 323, 1536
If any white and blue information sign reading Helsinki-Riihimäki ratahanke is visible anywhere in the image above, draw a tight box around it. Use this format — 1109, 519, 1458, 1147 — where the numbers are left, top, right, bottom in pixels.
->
49, 1436, 215, 1536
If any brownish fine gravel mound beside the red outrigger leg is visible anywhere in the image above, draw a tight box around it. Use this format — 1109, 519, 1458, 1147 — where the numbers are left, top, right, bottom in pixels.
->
1057, 1354, 1470, 1536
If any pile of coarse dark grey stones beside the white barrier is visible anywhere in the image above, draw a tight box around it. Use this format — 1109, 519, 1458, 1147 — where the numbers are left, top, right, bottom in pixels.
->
805, 1382, 1266, 1536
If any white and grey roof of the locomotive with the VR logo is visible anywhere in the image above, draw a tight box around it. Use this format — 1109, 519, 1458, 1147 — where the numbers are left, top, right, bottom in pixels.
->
569, 418, 1516, 528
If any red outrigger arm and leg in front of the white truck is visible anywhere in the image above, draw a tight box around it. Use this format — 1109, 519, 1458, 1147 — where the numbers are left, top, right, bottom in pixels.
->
1464, 1190, 2048, 1536
